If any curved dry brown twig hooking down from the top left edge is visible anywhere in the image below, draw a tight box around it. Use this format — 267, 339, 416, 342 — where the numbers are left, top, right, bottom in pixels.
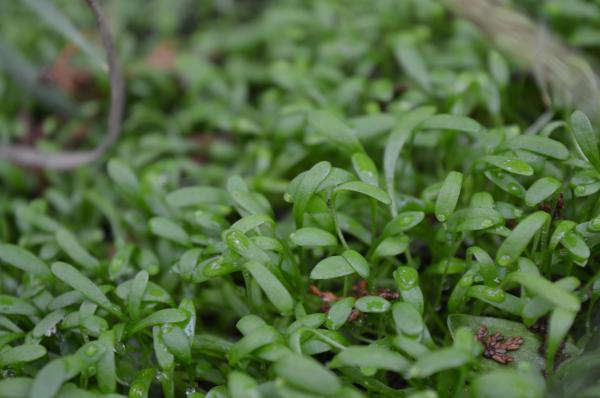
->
0, 0, 124, 170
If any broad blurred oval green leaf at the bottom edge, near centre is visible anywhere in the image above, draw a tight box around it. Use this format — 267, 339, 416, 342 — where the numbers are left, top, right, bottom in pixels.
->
275, 354, 342, 395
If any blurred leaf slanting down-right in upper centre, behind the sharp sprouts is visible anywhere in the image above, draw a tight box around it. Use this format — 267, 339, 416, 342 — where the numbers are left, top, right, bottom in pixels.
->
308, 111, 364, 153
